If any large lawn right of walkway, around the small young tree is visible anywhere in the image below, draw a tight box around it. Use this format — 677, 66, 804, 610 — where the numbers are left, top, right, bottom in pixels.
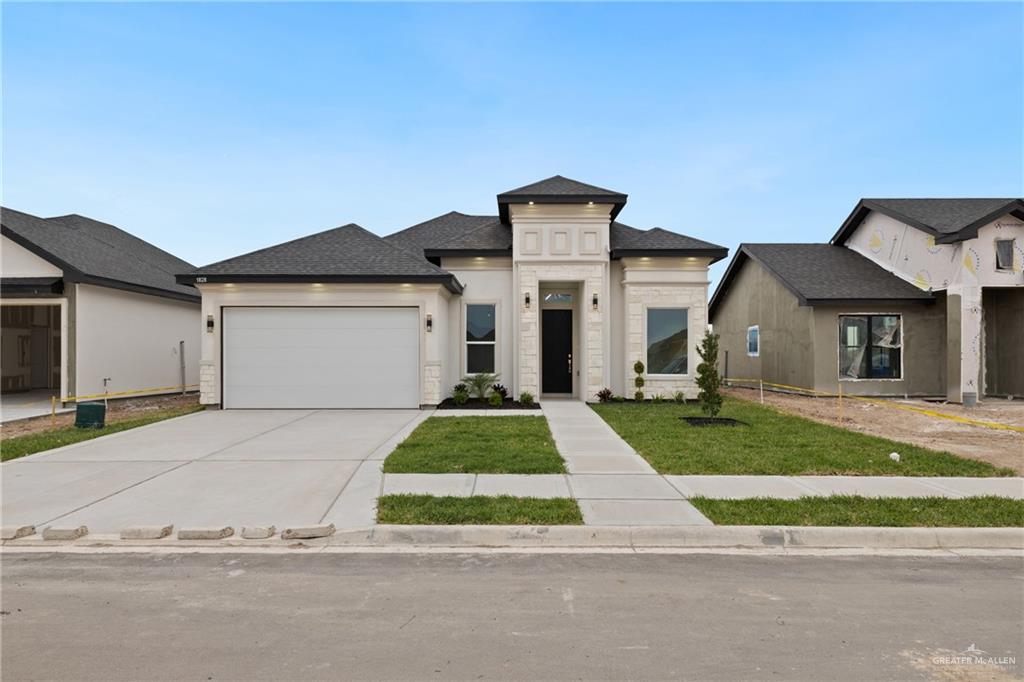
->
593, 398, 1014, 476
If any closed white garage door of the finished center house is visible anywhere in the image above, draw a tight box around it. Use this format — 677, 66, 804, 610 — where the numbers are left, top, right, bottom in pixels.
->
222, 307, 420, 408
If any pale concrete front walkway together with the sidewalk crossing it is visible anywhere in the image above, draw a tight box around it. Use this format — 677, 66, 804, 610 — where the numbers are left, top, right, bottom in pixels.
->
383, 399, 1024, 525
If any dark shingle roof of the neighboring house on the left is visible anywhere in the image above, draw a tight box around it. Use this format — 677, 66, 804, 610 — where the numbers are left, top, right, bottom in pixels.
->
0, 208, 200, 300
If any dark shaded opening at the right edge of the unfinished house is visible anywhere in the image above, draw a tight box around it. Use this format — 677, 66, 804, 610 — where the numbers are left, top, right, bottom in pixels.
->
981, 287, 1024, 396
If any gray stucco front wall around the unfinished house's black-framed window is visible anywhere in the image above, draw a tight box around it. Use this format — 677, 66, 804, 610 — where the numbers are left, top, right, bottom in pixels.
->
814, 293, 946, 396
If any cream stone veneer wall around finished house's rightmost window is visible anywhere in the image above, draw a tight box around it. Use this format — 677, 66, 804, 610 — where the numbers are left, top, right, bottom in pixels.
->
625, 281, 708, 398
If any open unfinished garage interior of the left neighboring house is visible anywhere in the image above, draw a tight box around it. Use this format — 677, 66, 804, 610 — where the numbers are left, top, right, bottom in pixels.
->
0, 304, 62, 397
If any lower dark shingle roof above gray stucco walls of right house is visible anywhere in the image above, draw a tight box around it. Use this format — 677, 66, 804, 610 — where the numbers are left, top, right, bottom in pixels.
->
709, 244, 934, 314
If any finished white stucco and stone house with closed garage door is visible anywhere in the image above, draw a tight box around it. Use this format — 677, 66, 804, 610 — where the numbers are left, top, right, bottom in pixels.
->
177, 176, 727, 408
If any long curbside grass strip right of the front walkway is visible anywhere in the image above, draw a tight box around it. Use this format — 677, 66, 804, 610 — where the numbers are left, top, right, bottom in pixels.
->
690, 496, 1024, 527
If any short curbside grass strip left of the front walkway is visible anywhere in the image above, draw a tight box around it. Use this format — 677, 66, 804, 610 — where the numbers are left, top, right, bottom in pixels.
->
377, 495, 583, 525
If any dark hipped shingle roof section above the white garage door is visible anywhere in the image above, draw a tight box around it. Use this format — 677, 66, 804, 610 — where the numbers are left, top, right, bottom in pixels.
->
179, 223, 462, 293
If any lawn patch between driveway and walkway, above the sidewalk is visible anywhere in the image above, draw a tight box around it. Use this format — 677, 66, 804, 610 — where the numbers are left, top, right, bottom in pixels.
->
384, 417, 565, 473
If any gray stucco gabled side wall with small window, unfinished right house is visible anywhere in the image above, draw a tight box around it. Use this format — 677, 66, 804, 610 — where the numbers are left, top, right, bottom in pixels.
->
712, 260, 814, 388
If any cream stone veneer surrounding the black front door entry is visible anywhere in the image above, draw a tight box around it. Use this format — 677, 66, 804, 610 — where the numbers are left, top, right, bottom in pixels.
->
515, 262, 610, 400
